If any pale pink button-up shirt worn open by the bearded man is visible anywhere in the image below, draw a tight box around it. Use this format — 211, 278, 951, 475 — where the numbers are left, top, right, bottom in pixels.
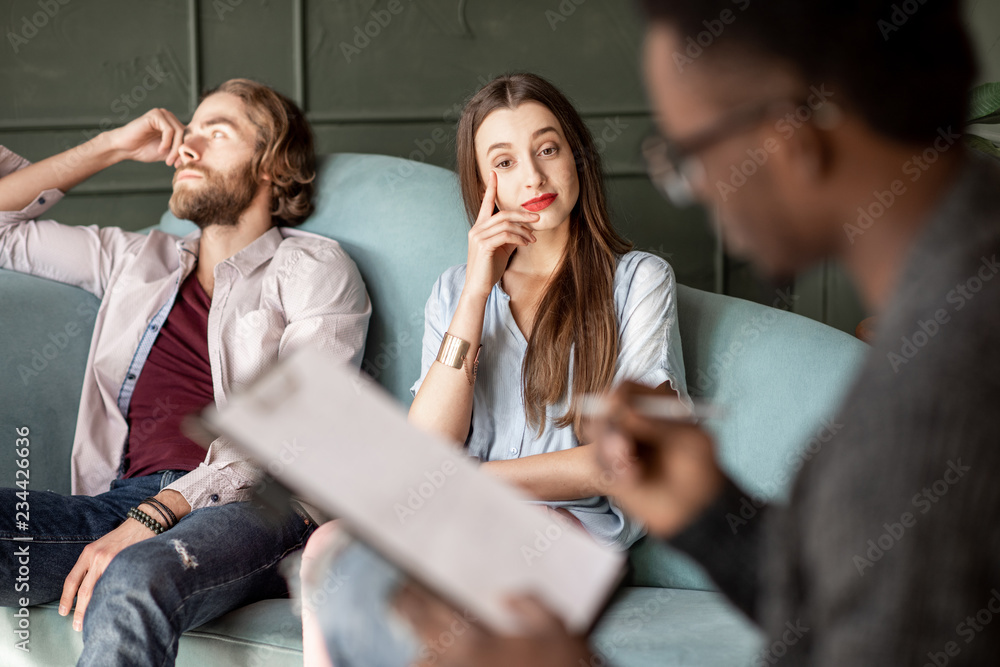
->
0, 146, 371, 509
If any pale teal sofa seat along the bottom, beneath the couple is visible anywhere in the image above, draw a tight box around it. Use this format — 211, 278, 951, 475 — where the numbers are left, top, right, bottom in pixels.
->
0, 588, 761, 667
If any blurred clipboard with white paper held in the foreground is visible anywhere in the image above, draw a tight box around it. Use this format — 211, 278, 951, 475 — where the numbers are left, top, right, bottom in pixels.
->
197, 347, 625, 635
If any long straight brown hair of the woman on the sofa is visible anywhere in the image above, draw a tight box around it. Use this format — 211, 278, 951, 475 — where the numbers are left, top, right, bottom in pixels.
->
456, 73, 632, 439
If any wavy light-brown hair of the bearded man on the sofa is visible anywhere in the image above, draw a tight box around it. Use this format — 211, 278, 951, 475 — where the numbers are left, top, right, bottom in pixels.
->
209, 79, 316, 227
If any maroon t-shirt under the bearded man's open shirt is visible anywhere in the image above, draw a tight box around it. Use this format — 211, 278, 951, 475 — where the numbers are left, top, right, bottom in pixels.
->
125, 271, 215, 477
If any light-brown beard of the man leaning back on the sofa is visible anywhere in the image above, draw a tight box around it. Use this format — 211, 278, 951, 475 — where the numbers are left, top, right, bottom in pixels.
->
170, 160, 257, 229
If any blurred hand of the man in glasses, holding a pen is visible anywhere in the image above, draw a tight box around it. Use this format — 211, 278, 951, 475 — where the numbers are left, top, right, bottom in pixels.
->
597, 382, 726, 538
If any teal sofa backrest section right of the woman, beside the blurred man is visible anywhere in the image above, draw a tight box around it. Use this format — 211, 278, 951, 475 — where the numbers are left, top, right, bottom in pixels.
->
630, 285, 868, 590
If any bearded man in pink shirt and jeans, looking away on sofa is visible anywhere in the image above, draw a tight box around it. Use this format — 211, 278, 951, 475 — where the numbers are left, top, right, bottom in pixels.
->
0, 79, 371, 666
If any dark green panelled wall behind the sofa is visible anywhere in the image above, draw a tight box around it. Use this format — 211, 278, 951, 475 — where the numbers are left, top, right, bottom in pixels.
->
0, 0, 1000, 331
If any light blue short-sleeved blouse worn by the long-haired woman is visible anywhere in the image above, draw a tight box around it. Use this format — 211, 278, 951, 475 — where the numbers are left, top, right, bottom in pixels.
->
410, 252, 690, 549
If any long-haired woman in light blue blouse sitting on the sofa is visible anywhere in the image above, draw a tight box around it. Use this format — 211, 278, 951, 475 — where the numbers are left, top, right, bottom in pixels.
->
303, 73, 690, 667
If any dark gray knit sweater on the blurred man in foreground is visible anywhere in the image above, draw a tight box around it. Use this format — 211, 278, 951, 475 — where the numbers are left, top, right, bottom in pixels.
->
670, 155, 1000, 667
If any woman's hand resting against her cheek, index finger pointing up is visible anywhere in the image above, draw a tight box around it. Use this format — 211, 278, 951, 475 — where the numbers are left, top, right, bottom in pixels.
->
465, 170, 540, 299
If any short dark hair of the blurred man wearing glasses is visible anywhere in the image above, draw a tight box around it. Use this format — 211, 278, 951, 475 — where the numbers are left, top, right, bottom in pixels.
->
640, 0, 977, 143
